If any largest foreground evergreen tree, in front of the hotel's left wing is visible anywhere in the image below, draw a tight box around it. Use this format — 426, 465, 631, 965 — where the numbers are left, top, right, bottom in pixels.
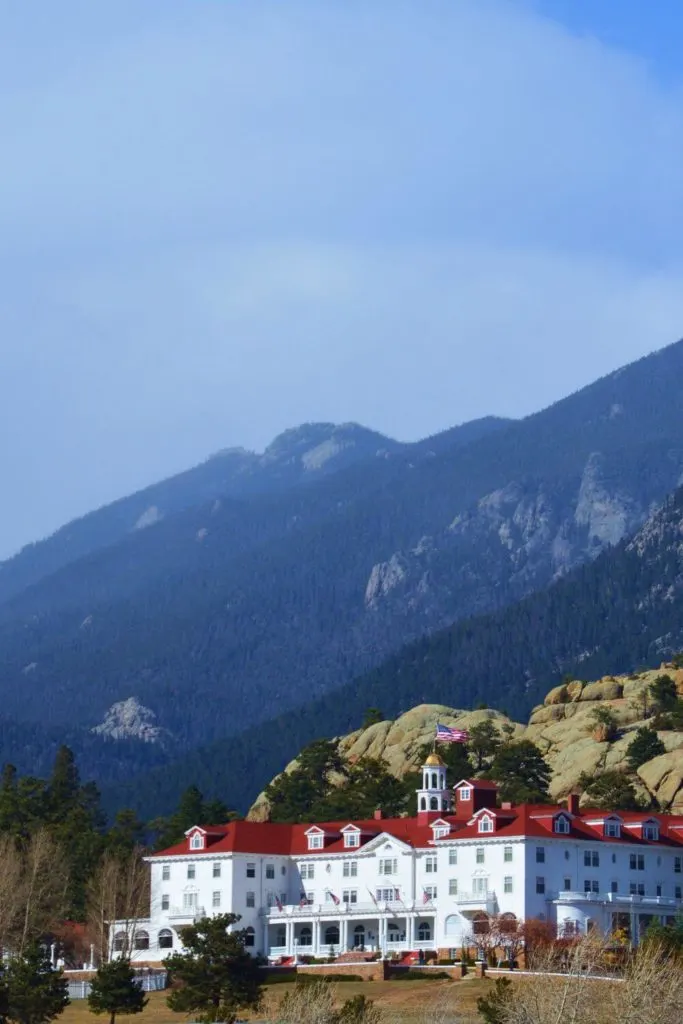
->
166, 913, 261, 1024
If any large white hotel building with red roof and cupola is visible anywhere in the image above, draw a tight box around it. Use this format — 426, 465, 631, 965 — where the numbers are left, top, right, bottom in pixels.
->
112, 754, 683, 963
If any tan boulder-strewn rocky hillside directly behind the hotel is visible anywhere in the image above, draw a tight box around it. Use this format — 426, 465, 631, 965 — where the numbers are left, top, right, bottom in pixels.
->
248, 663, 683, 821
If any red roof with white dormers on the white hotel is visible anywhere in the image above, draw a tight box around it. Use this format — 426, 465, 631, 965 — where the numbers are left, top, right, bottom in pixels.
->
152, 804, 683, 857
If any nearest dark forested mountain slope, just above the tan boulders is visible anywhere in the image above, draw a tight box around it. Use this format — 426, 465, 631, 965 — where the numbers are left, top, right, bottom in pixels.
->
108, 479, 683, 811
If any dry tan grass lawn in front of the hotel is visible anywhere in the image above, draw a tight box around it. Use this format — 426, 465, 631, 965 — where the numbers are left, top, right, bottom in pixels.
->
59, 978, 490, 1024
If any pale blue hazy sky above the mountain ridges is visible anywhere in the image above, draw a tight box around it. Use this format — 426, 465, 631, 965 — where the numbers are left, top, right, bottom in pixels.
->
0, 0, 683, 554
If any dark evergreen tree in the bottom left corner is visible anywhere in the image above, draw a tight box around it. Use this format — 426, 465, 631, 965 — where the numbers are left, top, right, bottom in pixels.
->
3, 944, 70, 1024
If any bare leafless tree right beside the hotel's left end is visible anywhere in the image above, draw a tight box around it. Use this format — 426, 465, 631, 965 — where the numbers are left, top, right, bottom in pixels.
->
87, 848, 150, 963
